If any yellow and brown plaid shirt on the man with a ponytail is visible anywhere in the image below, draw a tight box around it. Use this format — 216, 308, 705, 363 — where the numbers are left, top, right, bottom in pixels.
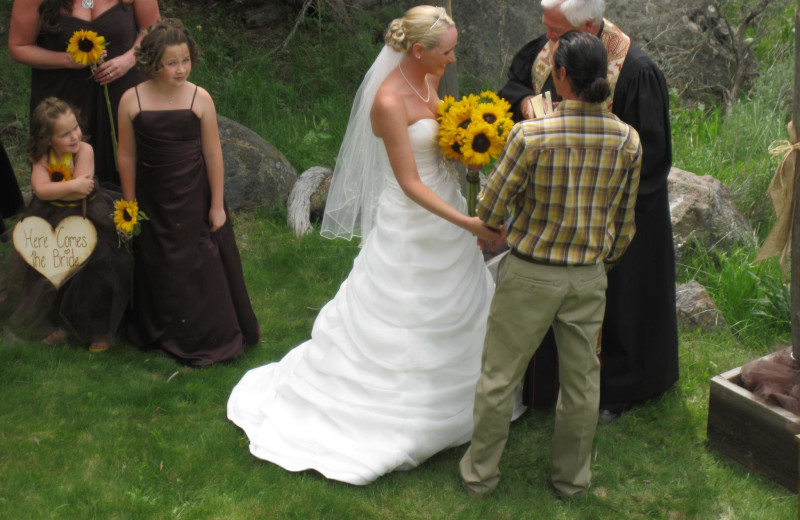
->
478, 100, 642, 265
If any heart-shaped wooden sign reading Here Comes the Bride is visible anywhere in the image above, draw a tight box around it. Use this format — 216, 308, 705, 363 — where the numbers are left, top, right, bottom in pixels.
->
12, 215, 97, 289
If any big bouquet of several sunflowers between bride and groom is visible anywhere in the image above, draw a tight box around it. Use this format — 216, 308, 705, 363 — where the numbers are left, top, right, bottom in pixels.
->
437, 90, 514, 216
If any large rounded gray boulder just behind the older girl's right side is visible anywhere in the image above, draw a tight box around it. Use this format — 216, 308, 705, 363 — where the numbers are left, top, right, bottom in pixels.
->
217, 115, 297, 211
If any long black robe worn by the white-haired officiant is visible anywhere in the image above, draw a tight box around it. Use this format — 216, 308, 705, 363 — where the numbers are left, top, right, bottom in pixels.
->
498, 29, 678, 413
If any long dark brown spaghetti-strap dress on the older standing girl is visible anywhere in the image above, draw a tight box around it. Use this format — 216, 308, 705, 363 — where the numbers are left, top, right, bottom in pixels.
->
129, 86, 260, 365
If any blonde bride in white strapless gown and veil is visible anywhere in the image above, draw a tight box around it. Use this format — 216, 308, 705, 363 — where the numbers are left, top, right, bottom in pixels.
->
228, 6, 498, 485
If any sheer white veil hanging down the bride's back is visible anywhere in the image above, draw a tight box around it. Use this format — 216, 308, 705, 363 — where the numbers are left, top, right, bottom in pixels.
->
320, 45, 403, 240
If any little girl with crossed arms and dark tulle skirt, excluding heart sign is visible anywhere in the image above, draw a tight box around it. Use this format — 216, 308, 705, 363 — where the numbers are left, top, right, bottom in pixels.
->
6, 97, 133, 352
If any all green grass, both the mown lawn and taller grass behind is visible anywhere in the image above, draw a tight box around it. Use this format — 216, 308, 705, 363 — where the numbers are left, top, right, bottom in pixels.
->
0, 0, 797, 520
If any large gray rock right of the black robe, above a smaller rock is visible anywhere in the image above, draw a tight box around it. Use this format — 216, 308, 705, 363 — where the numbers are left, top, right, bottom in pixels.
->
668, 168, 756, 260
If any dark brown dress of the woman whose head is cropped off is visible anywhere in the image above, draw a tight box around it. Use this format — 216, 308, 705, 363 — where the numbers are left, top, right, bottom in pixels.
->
30, 2, 145, 189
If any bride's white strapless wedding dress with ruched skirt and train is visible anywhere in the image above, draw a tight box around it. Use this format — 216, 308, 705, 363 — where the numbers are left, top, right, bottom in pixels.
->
228, 119, 494, 485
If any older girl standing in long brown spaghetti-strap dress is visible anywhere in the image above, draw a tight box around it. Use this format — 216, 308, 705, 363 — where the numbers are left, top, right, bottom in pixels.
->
119, 19, 260, 365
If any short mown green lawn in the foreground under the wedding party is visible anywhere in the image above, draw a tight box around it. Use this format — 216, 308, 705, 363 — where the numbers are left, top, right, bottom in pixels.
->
0, 212, 796, 520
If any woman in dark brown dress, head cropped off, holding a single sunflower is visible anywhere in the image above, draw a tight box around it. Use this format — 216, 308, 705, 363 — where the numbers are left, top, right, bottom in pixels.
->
8, 0, 160, 187
